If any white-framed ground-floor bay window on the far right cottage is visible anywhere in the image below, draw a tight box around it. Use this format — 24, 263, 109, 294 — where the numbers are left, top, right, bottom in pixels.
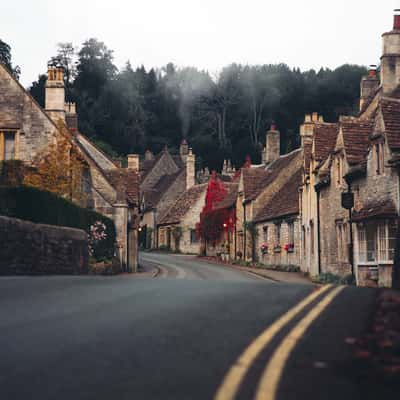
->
358, 220, 396, 263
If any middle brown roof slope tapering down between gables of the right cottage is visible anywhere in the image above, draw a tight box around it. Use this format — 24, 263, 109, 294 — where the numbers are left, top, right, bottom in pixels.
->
340, 119, 373, 165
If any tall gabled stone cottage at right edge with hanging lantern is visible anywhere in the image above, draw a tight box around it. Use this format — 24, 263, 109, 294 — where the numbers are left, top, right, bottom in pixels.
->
301, 11, 400, 286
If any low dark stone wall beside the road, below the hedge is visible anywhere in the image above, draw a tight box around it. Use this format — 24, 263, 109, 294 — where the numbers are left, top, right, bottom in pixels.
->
0, 216, 89, 275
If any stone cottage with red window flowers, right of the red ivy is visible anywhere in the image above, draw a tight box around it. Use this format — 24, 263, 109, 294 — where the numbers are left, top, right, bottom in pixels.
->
236, 124, 303, 265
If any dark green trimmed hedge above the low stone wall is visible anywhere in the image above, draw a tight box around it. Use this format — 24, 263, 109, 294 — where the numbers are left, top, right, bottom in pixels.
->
0, 186, 116, 259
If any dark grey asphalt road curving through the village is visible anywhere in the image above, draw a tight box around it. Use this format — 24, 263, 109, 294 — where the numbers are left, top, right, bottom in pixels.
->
0, 253, 375, 400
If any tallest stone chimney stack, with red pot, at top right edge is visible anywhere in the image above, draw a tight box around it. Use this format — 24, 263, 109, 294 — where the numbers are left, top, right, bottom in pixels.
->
381, 10, 400, 94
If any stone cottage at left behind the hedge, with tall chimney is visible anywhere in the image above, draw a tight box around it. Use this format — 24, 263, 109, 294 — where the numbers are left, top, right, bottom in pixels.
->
0, 64, 139, 271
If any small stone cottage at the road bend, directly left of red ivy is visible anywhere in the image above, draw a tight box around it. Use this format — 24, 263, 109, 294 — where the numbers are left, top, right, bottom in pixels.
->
157, 184, 207, 254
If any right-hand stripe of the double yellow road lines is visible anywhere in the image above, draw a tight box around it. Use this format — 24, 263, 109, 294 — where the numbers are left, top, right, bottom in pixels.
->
256, 286, 344, 400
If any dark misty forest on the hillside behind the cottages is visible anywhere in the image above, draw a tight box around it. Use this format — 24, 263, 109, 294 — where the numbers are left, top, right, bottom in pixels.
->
1, 39, 366, 169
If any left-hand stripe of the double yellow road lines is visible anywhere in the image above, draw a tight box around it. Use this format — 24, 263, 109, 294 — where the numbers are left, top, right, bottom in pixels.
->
214, 285, 332, 400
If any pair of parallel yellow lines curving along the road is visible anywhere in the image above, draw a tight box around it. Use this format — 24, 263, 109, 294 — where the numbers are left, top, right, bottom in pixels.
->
214, 285, 344, 400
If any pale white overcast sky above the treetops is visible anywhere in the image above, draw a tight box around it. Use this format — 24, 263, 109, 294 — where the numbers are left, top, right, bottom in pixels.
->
0, 0, 400, 86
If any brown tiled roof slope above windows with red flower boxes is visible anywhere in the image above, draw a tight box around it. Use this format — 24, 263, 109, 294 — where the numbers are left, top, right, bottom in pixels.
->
254, 168, 302, 222
